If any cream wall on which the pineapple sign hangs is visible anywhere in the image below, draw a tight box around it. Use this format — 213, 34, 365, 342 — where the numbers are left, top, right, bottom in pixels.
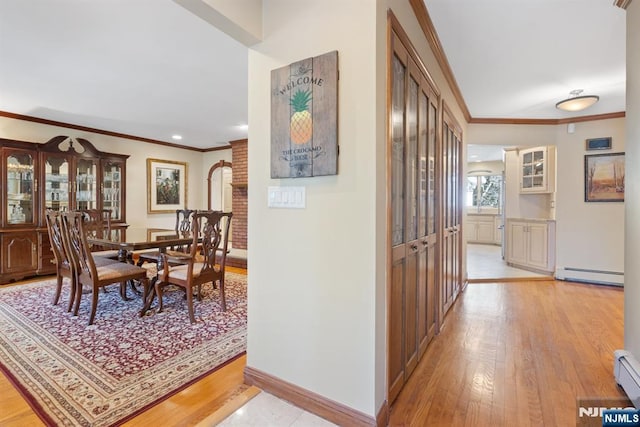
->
247, 0, 384, 416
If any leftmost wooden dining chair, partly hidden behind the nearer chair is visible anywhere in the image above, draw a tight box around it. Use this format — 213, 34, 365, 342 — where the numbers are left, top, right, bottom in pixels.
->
45, 209, 76, 311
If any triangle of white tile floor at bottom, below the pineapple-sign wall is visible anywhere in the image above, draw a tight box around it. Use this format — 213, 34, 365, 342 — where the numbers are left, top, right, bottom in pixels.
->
218, 391, 335, 427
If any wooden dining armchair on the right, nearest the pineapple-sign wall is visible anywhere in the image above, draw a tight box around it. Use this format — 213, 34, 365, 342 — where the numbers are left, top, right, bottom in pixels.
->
155, 211, 233, 323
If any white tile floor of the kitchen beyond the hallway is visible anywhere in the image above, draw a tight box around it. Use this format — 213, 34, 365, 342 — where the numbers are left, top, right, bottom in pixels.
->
467, 243, 545, 281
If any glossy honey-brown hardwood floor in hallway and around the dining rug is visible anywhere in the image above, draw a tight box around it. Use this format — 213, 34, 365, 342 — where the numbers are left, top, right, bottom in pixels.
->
0, 281, 624, 427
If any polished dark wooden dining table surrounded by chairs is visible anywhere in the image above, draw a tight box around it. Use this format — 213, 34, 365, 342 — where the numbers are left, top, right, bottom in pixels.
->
87, 227, 193, 316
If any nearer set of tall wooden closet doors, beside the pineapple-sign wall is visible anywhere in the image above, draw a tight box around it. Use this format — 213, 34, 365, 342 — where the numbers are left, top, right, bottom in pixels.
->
388, 23, 439, 401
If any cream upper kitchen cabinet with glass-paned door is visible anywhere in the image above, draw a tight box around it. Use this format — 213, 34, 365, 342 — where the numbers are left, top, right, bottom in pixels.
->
520, 146, 556, 194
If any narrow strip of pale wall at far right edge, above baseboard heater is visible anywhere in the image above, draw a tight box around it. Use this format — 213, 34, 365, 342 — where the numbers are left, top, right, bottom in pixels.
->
624, 1, 640, 360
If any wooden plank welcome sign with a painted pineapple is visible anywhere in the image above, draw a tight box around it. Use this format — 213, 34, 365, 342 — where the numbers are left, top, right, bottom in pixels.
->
271, 51, 338, 178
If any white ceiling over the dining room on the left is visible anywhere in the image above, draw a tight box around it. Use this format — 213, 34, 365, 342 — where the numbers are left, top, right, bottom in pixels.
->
0, 0, 248, 148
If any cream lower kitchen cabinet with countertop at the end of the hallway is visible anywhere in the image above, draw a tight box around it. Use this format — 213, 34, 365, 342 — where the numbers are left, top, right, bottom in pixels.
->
505, 218, 555, 274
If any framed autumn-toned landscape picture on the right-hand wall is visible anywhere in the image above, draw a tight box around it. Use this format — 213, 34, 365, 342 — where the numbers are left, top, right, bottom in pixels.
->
584, 153, 624, 202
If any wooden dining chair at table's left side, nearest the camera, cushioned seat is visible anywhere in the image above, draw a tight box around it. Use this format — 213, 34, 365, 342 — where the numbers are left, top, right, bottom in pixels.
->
62, 212, 149, 325
